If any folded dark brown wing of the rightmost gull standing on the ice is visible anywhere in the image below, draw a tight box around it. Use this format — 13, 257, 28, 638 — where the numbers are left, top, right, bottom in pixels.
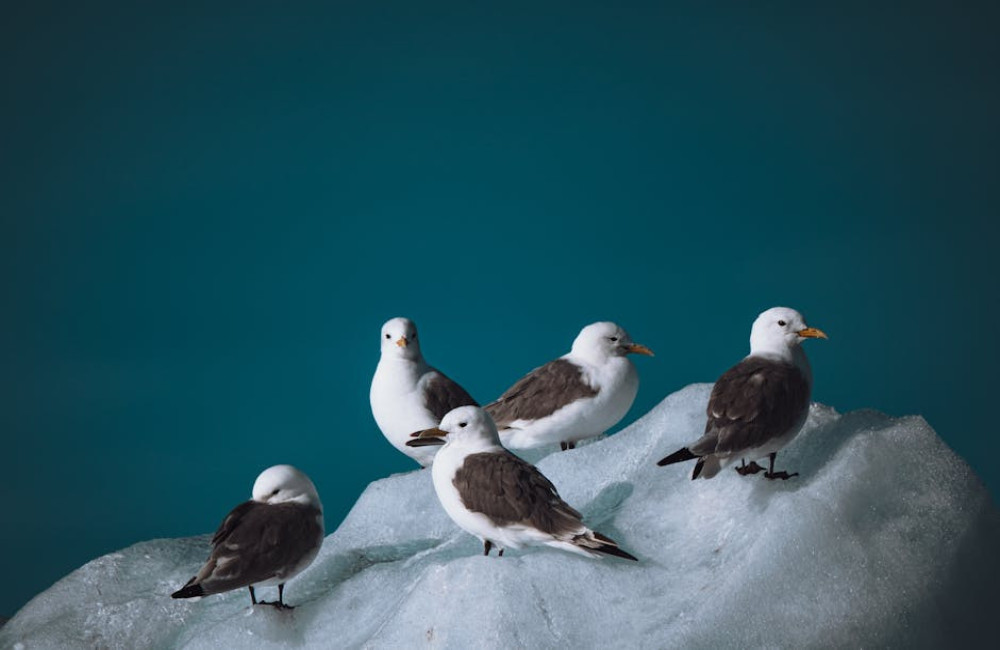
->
690, 357, 810, 456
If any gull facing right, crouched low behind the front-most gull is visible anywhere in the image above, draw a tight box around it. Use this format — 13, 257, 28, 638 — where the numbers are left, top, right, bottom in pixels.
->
486, 322, 653, 451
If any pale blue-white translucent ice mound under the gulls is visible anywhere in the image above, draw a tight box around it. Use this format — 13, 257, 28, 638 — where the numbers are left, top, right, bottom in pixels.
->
0, 384, 1000, 648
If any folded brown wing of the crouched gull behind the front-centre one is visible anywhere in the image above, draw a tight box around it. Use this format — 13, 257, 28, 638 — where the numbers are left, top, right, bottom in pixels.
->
486, 359, 597, 429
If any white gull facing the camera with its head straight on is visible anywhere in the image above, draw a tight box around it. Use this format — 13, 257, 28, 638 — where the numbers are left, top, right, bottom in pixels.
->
369, 318, 478, 467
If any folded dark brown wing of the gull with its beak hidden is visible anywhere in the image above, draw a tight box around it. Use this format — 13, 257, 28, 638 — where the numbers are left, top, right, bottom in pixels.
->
189, 501, 320, 594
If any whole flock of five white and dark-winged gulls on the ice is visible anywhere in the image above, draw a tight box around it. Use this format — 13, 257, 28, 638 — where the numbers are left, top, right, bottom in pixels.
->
172, 307, 827, 608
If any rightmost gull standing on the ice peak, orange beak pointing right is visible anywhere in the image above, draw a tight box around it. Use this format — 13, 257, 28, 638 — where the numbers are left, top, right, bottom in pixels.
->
657, 307, 827, 480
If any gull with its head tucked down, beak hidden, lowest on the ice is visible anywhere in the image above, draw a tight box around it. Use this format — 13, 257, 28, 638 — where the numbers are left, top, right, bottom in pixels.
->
171, 465, 323, 609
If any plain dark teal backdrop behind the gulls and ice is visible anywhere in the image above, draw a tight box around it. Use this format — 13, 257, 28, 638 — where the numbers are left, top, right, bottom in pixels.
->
0, 1, 1000, 615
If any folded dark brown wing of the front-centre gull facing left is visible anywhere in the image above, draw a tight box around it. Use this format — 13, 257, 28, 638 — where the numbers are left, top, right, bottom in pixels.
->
452, 451, 583, 537
